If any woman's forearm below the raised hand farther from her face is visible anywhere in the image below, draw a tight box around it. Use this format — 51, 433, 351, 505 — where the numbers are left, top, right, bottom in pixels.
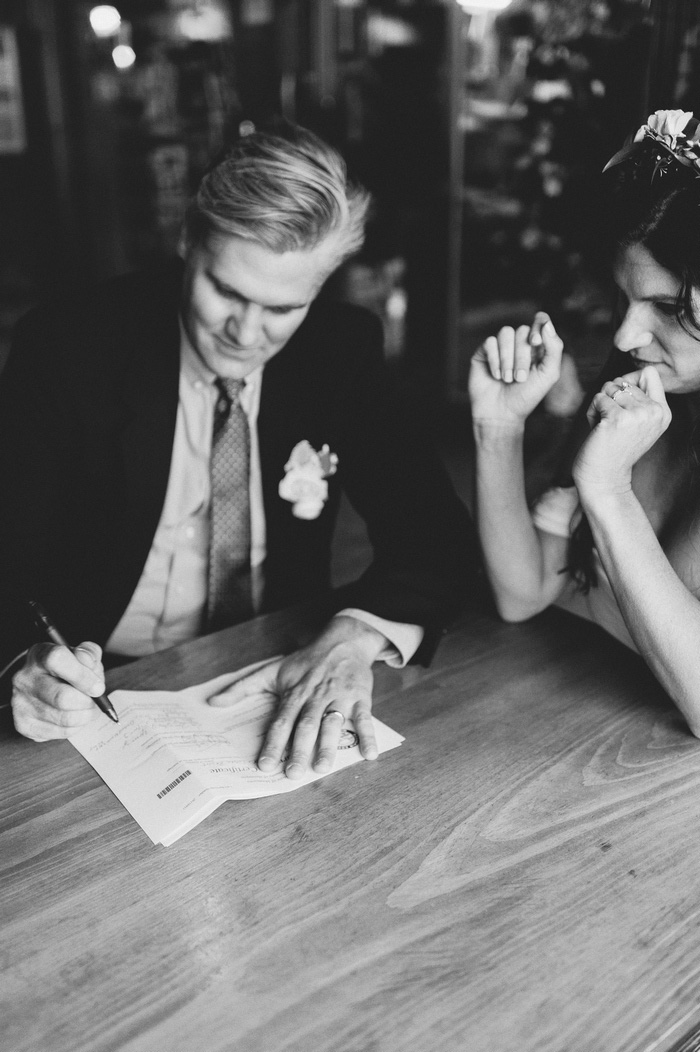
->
474, 422, 564, 621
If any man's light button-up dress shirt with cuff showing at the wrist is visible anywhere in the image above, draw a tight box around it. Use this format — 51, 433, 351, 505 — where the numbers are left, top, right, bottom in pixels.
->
105, 332, 423, 667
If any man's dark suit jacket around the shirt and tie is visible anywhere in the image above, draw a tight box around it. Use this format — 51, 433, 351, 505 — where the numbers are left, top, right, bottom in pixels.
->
0, 264, 475, 660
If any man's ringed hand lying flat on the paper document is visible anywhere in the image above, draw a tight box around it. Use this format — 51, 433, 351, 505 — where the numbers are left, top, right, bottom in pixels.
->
209, 616, 387, 778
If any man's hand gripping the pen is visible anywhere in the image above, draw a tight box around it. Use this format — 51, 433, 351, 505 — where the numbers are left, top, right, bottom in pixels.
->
12, 643, 105, 742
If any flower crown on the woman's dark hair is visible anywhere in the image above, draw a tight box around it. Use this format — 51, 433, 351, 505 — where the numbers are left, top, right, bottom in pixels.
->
603, 109, 700, 180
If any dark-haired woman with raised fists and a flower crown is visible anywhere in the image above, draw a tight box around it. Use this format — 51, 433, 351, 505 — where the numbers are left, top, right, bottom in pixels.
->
469, 110, 700, 736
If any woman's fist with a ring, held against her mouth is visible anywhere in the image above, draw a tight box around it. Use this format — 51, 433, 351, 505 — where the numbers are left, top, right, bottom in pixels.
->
574, 365, 671, 499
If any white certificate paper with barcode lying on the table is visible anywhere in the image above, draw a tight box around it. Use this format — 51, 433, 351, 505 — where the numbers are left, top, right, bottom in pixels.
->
69, 666, 403, 846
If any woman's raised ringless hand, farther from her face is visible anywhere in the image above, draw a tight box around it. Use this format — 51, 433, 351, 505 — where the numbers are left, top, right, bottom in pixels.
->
469, 311, 563, 425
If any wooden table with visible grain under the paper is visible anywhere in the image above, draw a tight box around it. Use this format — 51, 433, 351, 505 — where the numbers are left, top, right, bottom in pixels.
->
0, 609, 700, 1052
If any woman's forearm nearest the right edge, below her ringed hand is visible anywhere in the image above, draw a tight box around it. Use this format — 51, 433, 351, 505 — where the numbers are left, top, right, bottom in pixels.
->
582, 490, 700, 736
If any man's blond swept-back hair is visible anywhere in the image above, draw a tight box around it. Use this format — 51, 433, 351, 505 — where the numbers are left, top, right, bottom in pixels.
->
185, 122, 369, 269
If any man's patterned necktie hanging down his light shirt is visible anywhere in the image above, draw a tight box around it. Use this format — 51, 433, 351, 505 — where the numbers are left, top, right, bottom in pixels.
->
207, 378, 254, 632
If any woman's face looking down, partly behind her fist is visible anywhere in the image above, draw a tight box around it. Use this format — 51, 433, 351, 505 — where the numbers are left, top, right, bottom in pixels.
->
615, 245, 700, 395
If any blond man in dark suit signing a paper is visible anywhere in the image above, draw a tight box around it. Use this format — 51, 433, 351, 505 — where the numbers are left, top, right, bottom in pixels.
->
0, 127, 474, 777
